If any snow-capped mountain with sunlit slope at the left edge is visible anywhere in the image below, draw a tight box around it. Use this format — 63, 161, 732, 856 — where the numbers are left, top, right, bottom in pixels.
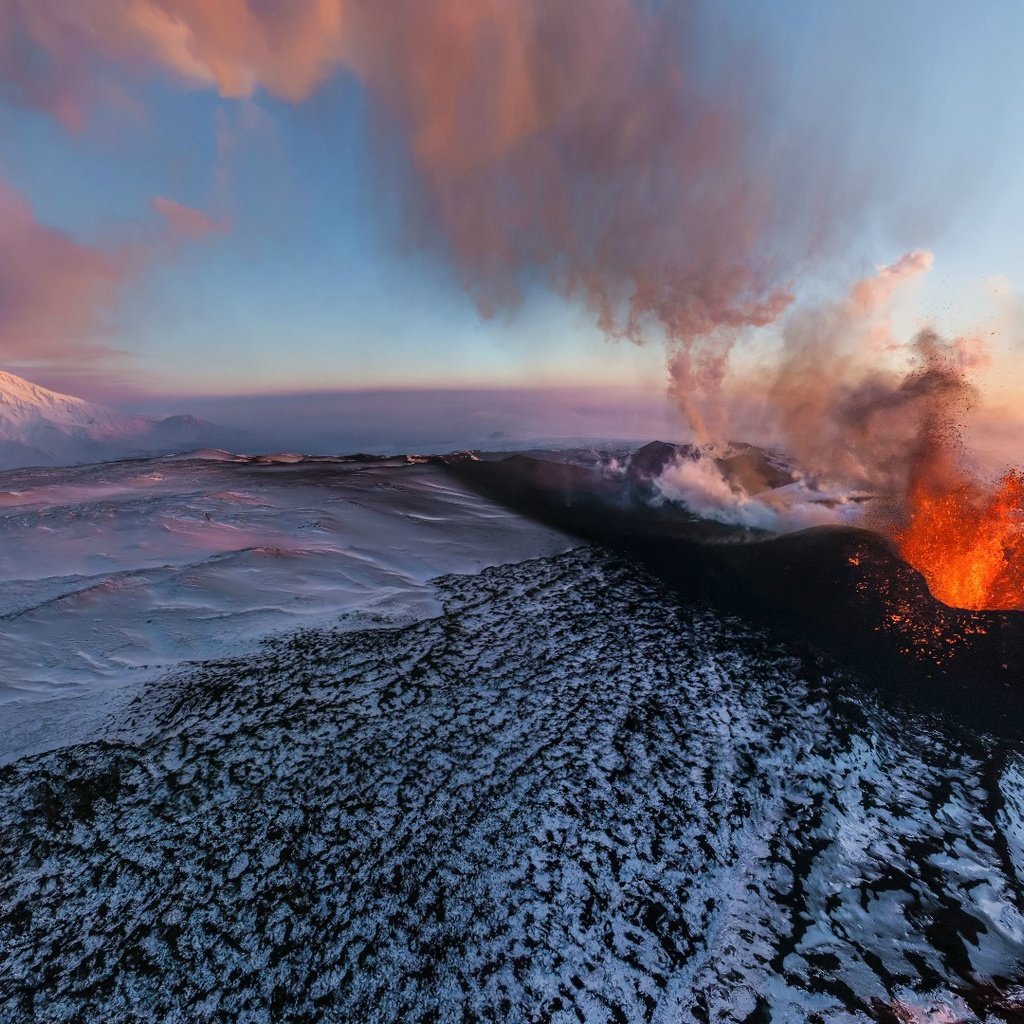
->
0, 371, 237, 469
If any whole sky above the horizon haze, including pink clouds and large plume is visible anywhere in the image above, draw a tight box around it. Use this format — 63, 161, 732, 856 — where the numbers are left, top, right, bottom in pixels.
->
0, 0, 1024, 444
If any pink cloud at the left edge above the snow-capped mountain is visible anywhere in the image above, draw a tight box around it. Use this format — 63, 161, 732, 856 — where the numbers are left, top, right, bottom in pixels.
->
0, 182, 125, 360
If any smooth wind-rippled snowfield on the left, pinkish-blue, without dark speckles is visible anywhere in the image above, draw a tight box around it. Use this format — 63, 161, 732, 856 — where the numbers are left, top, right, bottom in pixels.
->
0, 452, 573, 760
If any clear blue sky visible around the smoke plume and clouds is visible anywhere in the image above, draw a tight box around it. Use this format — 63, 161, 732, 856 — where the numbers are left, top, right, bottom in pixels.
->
0, 0, 1024, 407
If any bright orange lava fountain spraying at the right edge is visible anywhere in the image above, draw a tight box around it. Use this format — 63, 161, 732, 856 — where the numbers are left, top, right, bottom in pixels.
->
895, 470, 1024, 610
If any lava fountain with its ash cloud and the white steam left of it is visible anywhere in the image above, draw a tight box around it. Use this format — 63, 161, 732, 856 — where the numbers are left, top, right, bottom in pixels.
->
657, 251, 1024, 609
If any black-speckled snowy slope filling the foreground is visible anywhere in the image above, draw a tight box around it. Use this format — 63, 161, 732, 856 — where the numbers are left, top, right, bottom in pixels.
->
0, 550, 1024, 1024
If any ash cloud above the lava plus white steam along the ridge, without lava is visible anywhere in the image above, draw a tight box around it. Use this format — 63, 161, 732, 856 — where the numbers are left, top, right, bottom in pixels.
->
657, 250, 989, 538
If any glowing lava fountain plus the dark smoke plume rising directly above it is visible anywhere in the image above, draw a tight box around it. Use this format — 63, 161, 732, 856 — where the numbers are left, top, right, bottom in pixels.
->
769, 252, 1024, 609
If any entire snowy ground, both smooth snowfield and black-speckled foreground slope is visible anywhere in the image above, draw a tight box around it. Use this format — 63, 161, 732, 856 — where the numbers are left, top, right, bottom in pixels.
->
0, 452, 1024, 1024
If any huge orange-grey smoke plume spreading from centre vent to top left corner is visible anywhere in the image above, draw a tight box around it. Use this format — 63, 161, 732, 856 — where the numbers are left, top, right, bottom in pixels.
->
0, 0, 828, 415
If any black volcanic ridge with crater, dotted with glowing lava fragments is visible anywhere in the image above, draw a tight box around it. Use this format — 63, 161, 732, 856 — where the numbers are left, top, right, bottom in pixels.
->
449, 442, 1024, 735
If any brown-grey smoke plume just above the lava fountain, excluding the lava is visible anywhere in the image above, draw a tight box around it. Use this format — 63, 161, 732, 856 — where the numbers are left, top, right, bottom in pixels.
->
765, 251, 985, 512
